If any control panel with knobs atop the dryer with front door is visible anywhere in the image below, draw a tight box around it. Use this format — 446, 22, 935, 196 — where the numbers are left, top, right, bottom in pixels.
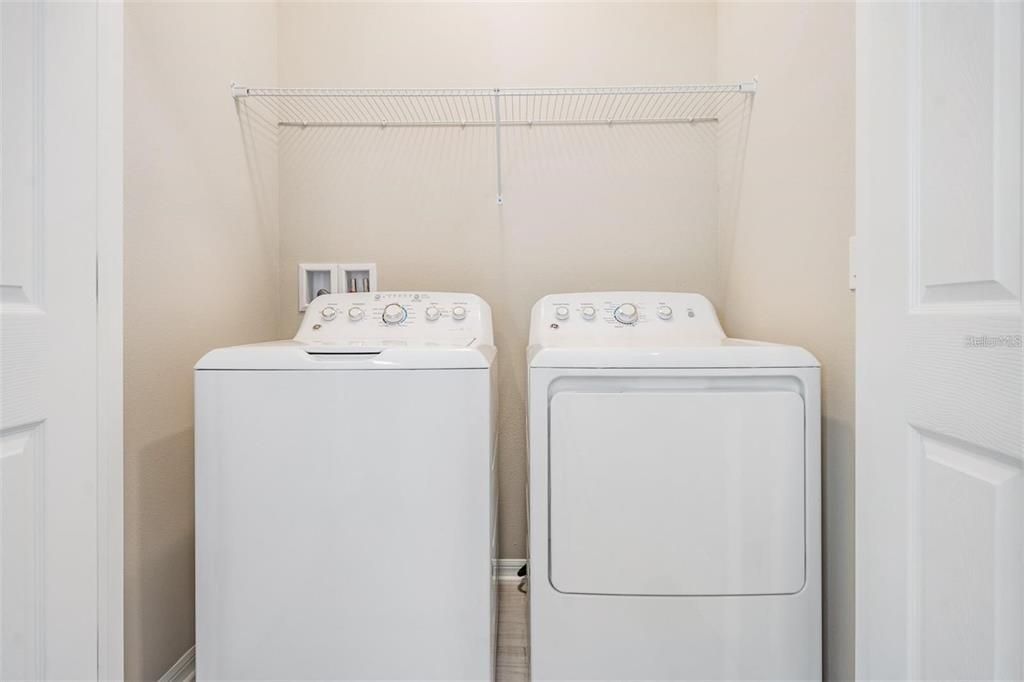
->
529, 292, 725, 347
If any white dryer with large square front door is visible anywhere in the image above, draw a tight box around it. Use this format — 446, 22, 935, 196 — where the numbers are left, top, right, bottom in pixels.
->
528, 293, 821, 680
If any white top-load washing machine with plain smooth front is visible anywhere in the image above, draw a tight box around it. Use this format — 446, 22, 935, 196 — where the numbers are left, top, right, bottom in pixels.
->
195, 292, 497, 680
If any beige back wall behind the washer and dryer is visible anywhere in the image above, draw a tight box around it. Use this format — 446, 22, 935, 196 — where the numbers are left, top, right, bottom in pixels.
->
280, 3, 719, 557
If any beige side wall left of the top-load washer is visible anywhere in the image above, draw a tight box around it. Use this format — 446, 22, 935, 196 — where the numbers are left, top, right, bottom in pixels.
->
124, 3, 280, 680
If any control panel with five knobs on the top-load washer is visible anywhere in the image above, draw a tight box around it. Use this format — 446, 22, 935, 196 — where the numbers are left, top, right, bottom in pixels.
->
295, 292, 494, 347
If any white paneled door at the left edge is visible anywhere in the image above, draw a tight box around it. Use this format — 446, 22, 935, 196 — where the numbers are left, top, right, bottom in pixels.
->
0, 3, 105, 679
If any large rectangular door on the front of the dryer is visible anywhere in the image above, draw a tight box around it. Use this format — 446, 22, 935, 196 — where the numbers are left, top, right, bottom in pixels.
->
549, 389, 805, 595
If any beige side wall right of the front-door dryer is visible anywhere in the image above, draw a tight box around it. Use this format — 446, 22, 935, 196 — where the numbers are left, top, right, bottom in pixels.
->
718, 3, 854, 679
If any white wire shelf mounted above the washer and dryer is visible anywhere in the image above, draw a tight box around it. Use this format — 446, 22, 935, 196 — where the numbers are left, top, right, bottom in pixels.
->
230, 78, 758, 205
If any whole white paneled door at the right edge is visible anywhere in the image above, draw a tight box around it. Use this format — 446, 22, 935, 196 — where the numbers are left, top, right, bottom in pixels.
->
857, 3, 1024, 679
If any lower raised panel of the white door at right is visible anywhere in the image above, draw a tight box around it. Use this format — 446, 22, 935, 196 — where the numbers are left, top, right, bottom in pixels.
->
907, 426, 1024, 679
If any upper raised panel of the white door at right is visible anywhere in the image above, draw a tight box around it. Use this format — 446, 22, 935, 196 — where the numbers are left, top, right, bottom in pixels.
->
906, 3, 1024, 314
